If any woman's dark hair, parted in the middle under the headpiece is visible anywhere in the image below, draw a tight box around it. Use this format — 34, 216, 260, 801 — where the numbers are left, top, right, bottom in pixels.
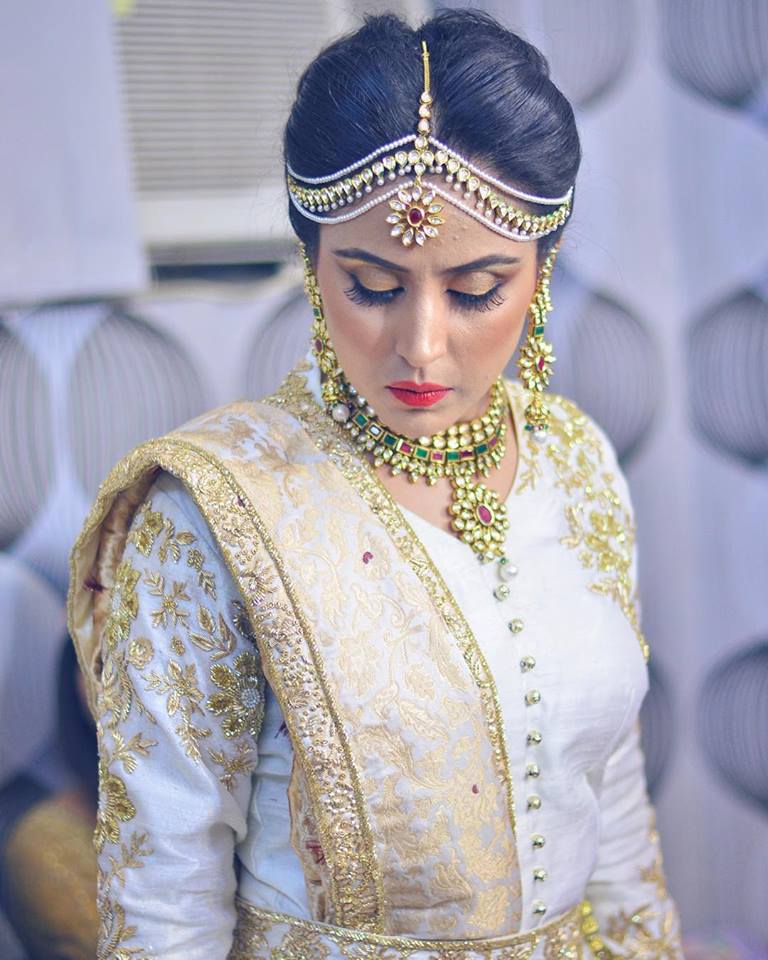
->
283, 9, 581, 260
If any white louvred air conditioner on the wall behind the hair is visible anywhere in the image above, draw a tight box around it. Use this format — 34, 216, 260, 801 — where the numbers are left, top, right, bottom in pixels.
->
113, 0, 431, 264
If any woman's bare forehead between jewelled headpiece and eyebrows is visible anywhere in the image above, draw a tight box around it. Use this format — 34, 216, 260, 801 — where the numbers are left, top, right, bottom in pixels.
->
320, 175, 536, 272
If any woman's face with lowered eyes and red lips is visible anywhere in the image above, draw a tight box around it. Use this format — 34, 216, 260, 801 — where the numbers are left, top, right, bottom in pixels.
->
315, 188, 537, 438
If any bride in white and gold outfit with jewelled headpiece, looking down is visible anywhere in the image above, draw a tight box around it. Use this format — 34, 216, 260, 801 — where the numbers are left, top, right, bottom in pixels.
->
68, 11, 682, 960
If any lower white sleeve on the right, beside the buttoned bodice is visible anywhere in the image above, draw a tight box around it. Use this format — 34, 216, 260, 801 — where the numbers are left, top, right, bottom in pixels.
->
587, 721, 683, 960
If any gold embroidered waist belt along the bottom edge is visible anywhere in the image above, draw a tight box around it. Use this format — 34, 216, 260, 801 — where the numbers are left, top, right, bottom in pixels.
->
228, 900, 589, 960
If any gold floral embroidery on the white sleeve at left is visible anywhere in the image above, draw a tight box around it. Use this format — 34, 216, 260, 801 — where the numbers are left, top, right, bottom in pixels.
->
82, 492, 266, 960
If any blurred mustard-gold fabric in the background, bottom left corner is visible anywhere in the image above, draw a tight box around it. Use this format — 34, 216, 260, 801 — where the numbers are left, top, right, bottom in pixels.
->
3, 797, 99, 960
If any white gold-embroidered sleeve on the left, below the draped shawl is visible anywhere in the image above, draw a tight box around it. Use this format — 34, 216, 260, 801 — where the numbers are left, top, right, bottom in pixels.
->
94, 473, 264, 960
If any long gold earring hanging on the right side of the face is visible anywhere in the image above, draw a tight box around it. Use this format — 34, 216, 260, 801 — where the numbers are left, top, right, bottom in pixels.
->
517, 240, 560, 440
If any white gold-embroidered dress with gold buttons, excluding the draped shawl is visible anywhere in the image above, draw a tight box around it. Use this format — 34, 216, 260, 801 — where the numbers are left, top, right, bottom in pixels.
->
90, 370, 682, 960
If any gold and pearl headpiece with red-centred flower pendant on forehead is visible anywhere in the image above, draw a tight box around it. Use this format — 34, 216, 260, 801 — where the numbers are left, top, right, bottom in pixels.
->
287, 40, 573, 247
